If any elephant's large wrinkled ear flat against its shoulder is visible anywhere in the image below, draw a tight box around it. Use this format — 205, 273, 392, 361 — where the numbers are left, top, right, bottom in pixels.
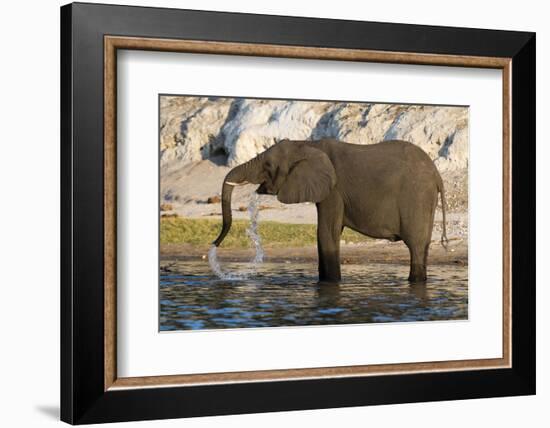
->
277, 143, 336, 204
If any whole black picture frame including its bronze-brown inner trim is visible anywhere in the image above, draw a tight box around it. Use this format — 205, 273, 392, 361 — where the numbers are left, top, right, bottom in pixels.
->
61, 3, 536, 424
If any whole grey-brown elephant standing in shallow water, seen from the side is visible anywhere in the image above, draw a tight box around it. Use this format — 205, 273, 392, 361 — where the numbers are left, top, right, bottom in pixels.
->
214, 140, 447, 282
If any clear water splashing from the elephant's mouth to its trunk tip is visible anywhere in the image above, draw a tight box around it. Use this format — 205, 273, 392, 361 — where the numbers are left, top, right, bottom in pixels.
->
208, 192, 264, 281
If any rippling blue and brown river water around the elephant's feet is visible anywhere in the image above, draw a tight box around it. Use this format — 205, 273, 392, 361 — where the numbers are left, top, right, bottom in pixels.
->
160, 261, 468, 331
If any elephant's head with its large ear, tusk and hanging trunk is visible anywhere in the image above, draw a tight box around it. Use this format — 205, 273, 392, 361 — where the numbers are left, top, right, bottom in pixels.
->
214, 140, 336, 246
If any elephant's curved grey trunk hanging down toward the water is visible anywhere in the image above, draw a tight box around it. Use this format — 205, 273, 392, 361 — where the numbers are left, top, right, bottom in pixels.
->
213, 158, 260, 247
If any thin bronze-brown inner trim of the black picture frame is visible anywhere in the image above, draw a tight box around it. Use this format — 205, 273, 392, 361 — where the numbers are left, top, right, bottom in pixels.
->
104, 36, 512, 391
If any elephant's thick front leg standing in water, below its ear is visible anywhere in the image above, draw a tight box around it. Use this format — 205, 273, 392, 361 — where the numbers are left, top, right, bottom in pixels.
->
317, 190, 344, 282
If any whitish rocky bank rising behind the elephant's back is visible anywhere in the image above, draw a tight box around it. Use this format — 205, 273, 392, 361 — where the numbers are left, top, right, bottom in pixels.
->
160, 96, 468, 171
